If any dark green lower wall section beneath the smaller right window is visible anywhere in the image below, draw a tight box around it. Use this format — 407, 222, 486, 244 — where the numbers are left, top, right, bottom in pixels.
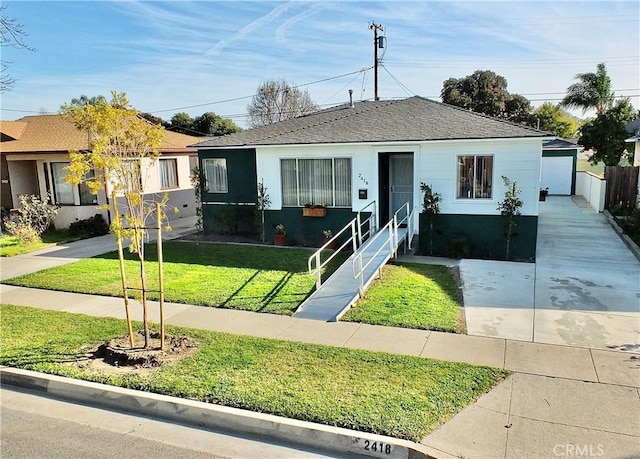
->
418, 214, 538, 261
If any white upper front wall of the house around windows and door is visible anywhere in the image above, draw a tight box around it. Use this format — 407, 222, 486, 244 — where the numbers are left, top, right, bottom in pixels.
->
256, 139, 542, 216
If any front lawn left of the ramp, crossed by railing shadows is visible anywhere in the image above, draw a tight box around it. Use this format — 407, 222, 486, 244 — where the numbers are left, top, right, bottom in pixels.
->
5, 241, 344, 315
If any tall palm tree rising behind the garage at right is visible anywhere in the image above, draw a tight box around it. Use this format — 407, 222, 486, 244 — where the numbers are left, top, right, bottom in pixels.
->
560, 63, 614, 115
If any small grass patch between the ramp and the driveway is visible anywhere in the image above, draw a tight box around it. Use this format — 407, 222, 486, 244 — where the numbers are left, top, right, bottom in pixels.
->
341, 263, 460, 332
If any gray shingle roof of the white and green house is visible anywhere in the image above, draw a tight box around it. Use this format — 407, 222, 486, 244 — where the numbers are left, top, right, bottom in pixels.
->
195, 96, 550, 148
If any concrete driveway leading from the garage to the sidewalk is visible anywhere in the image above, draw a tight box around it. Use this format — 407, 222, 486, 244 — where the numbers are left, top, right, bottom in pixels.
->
460, 196, 640, 351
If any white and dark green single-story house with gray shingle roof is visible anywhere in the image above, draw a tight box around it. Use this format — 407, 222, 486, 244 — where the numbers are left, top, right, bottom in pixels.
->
195, 97, 553, 259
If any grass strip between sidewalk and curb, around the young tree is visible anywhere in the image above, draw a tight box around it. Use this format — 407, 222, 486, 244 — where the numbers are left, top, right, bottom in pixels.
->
0, 305, 506, 441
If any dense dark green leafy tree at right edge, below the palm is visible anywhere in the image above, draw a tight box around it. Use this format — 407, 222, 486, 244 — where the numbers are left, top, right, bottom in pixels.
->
579, 99, 637, 166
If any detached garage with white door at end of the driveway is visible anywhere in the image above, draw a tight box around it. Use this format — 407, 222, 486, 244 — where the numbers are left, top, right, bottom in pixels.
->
540, 139, 582, 196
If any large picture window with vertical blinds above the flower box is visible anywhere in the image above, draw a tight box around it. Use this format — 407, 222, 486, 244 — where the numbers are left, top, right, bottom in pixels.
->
280, 158, 351, 207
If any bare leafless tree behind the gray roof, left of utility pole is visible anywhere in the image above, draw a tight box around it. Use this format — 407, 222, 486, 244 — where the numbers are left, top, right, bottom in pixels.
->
247, 79, 318, 127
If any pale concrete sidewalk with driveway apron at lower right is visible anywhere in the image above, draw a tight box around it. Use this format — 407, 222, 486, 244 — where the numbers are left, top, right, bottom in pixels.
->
0, 223, 640, 458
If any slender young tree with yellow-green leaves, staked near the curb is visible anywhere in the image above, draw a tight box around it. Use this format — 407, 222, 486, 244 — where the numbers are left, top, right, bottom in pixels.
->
61, 91, 167, 348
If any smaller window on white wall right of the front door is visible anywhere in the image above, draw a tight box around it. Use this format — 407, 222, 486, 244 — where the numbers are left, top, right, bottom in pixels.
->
458, 156, 493, 199
